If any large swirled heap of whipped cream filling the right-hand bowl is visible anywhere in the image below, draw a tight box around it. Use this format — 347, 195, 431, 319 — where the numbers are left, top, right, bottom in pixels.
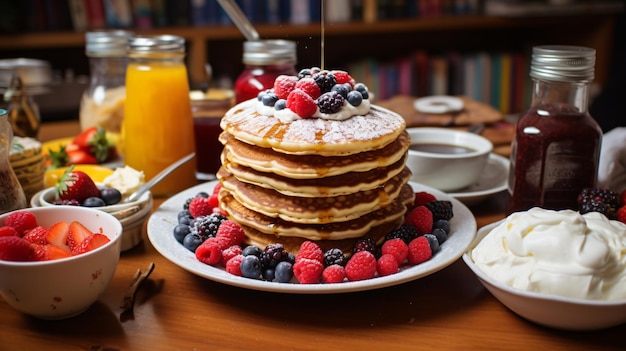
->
471, 208, 626, 300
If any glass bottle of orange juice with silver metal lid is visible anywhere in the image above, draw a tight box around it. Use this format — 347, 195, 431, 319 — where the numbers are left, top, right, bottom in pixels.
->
121, 35, 197, 196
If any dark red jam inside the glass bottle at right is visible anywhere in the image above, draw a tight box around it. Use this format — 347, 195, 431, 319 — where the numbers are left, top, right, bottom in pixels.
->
509, 104, 602, 212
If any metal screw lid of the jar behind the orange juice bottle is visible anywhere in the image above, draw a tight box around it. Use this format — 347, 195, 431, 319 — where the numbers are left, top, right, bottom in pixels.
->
85, 30, 133, 57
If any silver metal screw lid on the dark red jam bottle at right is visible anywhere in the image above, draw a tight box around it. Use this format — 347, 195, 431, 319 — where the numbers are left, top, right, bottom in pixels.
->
530, 45, 596, 82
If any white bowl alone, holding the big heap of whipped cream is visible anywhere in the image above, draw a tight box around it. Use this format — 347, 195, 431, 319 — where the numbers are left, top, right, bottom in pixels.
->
463, 222, 626, 331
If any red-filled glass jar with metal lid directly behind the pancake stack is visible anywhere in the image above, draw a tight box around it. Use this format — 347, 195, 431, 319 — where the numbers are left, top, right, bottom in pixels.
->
235, 40, 297, 103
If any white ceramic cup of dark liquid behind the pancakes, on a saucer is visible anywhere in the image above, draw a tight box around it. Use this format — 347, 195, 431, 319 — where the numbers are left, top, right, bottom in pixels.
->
406, 127, 493, 192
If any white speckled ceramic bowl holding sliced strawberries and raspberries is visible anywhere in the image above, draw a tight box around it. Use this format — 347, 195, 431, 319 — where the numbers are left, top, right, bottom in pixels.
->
0, 206, 122, 319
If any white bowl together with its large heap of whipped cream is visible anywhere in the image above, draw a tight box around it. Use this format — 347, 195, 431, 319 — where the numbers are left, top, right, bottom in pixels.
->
463, 208, 626, 330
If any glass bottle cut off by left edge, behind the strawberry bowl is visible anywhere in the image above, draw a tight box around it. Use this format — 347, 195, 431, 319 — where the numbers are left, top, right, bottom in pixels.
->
0, 109, 26, 213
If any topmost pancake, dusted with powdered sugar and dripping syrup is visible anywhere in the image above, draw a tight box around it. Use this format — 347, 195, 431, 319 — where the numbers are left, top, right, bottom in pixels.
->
220, 99, 405, 156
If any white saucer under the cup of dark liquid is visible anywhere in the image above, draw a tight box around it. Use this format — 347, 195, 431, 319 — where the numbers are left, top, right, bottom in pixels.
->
447, 153, 509, 206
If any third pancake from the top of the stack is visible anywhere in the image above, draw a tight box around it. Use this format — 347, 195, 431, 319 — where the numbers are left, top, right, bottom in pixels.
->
217, 151, 406, 197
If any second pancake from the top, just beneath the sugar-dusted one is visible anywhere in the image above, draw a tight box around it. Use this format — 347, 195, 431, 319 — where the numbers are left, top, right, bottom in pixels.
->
220, 129, 411, 179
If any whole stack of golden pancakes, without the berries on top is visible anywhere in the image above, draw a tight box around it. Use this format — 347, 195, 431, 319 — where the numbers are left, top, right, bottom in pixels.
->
217, 100, 414, 253
